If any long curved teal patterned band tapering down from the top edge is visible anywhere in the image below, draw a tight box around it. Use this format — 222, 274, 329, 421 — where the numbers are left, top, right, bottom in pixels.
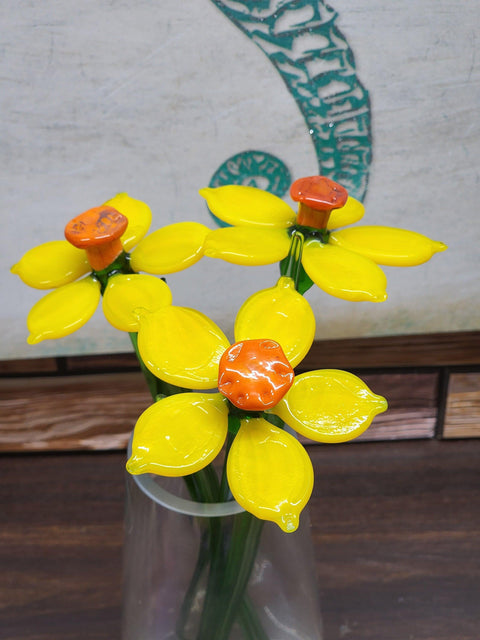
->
212, 0, 372, 200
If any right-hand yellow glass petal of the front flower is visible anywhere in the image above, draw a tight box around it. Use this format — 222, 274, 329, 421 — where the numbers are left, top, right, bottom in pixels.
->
271, 369, 387, 442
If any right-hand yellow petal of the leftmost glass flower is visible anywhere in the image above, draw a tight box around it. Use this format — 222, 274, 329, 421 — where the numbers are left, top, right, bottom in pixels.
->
131, 222, 210, 275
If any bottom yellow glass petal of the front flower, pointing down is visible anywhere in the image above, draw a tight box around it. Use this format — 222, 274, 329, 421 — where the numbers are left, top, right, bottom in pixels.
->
227, 418, 313, 532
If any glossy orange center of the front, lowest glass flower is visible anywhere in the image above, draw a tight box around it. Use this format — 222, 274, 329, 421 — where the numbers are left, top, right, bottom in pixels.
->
218, 339, 294, 411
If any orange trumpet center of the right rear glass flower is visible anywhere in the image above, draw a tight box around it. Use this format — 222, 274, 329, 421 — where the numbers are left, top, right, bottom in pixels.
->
290, 176, 348, 229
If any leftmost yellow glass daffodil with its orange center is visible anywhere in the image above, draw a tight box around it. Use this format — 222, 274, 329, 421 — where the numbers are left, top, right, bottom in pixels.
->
11, 193, 210, 344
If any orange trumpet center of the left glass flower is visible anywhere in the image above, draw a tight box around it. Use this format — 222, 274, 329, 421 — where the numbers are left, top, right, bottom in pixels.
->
65, 205, 128, 271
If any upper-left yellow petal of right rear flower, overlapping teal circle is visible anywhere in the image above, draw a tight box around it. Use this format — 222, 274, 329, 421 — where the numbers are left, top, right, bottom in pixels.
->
199, 185, 295, 229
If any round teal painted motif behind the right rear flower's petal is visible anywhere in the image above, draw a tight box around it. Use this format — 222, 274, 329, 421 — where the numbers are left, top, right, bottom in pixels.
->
208, 151, 292, 227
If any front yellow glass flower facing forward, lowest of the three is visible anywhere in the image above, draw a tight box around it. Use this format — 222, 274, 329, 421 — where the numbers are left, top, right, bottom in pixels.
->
127, 277, 387, 531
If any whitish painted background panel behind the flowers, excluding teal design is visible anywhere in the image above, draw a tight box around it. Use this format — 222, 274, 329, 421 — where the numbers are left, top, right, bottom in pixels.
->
0, 0, 480, 359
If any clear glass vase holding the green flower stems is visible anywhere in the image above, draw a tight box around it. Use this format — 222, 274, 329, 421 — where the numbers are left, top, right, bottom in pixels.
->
122, 464, 322, 640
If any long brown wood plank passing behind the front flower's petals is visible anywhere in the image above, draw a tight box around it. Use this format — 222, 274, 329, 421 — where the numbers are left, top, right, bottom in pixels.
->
0, 372, 438, 451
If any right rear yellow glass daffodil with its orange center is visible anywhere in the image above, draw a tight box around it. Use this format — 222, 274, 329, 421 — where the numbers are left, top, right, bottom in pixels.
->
200, 176, 447, 302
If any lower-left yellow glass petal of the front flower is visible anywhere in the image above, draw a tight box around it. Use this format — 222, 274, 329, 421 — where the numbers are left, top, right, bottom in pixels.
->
127, 393, 228, 477
